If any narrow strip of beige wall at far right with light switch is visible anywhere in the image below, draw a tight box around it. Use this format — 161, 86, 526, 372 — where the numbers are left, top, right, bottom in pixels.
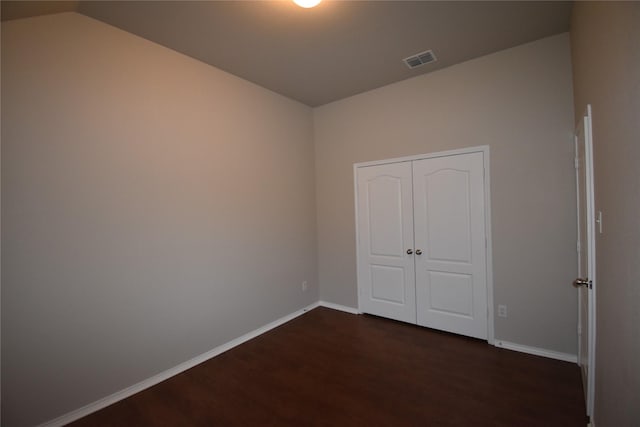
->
571, 2, 640, 427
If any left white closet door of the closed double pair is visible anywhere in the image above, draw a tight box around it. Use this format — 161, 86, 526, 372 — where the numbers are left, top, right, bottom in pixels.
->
357, 162, 416, 323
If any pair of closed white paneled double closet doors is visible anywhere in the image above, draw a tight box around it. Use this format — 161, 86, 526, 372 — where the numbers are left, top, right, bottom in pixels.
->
354, 150, 489, 339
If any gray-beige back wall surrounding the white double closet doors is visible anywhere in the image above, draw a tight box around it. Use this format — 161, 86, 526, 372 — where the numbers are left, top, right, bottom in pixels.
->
314, 34, 577, 354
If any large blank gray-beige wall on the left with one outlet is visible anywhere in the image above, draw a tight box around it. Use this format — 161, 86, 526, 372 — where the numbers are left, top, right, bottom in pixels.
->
2, 13, 318, 426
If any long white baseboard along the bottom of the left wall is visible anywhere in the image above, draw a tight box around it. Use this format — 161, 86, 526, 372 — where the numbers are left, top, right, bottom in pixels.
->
39, 302, 320, 427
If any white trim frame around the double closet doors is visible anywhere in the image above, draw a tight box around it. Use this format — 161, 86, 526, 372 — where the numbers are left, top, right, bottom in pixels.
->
353, 145, 495, 345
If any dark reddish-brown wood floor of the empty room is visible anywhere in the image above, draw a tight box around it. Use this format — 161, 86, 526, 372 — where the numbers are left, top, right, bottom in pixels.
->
72, 308, 586, 427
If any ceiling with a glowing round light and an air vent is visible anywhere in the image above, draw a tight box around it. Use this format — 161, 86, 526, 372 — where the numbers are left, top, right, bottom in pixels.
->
2, 0, 571, 106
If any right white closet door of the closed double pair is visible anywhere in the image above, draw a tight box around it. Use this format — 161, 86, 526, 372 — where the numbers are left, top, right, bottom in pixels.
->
413, 153, 487, 339
